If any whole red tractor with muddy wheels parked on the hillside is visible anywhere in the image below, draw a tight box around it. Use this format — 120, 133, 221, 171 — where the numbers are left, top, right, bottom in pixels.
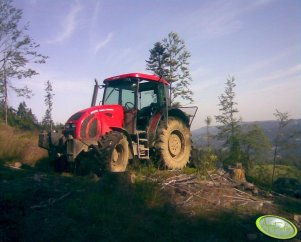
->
39, 73, 197, 172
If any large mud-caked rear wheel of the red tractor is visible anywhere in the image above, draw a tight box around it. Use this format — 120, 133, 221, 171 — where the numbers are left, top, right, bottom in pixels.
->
156, 117, 191, 169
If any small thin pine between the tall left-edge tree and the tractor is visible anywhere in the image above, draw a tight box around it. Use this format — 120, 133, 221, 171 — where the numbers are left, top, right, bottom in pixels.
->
42, 80, 54, 130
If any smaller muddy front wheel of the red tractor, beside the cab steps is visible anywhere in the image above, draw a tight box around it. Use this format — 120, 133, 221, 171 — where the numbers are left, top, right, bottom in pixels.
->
99, 131, 129, 172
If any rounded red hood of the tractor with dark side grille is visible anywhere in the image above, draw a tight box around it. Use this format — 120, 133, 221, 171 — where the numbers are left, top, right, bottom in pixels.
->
63, 105, 124, 140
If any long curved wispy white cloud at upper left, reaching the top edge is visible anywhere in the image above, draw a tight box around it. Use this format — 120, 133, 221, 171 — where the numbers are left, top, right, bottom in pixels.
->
47, 2, 82, 44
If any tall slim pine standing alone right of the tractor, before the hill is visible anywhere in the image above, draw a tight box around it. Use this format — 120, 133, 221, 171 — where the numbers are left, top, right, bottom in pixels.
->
215, 77, 241, 164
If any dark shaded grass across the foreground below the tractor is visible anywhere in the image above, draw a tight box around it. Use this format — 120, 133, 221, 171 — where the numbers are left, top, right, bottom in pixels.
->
0, 166, 292, 242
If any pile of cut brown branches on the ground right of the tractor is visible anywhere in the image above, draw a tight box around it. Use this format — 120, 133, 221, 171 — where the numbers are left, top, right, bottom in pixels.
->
160, 172, 271, 210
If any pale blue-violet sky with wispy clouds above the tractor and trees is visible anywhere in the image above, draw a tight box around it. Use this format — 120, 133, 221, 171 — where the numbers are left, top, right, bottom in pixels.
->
10, 0, 301, 129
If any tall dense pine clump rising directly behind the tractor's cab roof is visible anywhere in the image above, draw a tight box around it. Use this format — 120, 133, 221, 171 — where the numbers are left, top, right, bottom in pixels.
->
146, 32, 193, 106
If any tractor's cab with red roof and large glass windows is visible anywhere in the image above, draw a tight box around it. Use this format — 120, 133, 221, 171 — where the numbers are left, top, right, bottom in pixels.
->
92, 73, 168, 134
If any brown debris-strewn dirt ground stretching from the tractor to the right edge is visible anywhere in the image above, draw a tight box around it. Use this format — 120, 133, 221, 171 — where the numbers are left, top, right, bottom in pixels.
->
141, 170, 301, 242
